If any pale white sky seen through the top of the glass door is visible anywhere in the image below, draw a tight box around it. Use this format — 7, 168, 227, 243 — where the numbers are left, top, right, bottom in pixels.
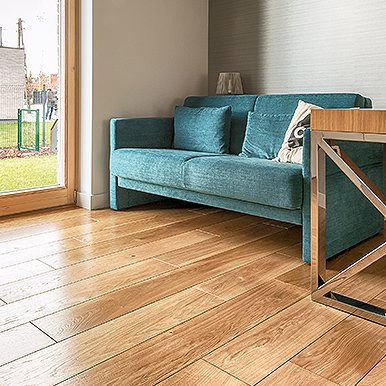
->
0, 0, 58, 76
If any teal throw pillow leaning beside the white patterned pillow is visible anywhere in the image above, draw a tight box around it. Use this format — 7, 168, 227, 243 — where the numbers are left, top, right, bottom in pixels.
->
240, 111, 292, 159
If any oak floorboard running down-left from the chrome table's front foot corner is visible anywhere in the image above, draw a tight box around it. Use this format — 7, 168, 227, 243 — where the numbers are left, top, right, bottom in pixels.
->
205, 298, 347, 384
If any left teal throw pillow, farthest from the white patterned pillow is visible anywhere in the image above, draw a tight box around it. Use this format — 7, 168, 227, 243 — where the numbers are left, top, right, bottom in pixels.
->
174, 106, 232, 153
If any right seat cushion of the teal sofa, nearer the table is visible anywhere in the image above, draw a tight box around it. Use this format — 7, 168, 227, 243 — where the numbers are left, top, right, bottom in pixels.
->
184, 155, 303, 209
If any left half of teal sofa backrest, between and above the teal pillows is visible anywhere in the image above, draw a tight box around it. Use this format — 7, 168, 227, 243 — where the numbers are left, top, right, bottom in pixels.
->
184, 95, 257, 154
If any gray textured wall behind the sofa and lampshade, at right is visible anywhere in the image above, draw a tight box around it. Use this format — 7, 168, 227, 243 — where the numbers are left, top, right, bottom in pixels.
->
209, 0, 386, 108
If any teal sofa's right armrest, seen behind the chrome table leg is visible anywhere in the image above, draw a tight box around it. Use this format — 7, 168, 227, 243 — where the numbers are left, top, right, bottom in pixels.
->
302, 129, 384, 262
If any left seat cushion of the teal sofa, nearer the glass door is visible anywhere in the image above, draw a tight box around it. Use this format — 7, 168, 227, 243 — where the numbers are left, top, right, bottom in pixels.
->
110, 148, 222, 188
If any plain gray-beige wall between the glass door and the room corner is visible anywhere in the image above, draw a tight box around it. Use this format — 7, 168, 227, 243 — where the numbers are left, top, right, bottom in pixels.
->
78, 0, 208, 209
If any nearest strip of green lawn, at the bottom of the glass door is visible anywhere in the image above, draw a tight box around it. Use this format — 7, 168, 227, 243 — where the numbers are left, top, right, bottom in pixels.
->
0, 154, 58, 192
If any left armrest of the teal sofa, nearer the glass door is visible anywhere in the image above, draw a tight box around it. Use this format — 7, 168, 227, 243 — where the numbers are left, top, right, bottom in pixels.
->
110, 118, 174, 151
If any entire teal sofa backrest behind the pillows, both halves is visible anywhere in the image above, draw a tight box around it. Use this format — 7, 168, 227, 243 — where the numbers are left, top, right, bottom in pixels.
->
184, 93, 371, 154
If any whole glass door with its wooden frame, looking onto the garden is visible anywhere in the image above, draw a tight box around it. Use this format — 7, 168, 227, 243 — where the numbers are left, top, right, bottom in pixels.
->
0, 0, 77, 216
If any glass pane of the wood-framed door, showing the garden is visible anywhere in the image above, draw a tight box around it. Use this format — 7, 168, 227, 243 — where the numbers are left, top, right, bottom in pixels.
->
0, 0, 63, 193
